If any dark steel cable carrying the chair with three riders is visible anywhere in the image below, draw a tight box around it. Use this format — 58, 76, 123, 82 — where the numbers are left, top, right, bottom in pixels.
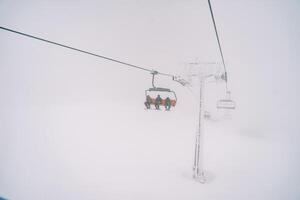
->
0, 26, 174, 77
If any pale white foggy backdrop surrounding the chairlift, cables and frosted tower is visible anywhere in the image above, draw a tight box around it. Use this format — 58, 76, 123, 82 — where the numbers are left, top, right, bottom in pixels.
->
0, 0, 300, 200
